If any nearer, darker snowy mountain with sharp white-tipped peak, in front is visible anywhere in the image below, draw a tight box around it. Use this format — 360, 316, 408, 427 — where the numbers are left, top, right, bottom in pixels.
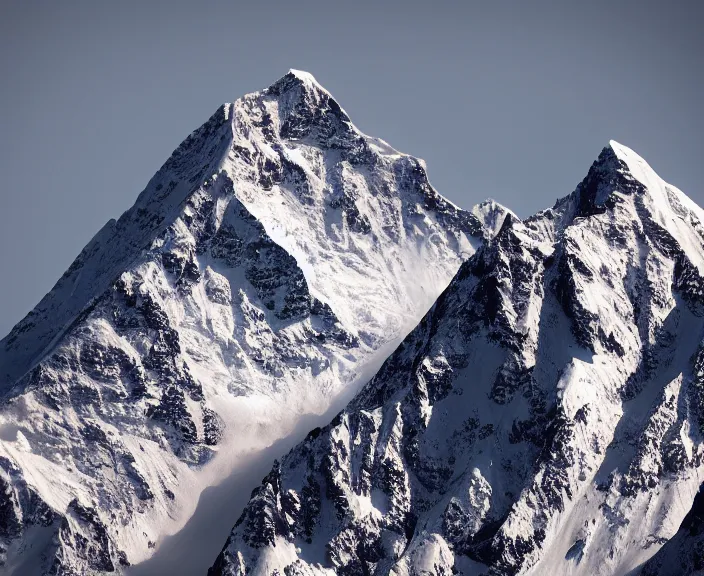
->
209, 142, 704, 576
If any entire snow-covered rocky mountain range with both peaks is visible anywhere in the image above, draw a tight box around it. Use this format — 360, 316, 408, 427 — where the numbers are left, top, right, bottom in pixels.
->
0, 70, 704, 576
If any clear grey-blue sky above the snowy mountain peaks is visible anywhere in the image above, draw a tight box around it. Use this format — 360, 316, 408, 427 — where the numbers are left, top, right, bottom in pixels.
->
0, 0, 704, 337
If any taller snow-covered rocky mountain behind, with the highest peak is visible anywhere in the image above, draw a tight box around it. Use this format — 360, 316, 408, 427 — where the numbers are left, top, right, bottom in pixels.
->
0, 70, 500, 575
